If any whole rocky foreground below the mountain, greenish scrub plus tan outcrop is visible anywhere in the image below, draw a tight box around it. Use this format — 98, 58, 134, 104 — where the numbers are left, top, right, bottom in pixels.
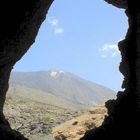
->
4, 96, 107, 140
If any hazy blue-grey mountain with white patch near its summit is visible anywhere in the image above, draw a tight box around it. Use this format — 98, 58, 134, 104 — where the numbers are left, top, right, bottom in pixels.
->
9, 70, 115, 108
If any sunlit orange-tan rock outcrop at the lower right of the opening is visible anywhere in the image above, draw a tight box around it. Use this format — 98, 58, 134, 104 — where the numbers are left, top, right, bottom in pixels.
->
52, 105, 107, 140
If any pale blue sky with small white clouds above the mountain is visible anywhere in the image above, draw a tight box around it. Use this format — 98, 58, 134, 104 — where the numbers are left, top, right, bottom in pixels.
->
14, 0, 128, 91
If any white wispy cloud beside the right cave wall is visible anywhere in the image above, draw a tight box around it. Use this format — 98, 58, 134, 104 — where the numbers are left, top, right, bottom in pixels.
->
98, 44, 120, 58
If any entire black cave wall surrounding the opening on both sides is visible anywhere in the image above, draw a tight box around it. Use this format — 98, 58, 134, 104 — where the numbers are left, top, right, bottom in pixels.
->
0, 0, 140, 140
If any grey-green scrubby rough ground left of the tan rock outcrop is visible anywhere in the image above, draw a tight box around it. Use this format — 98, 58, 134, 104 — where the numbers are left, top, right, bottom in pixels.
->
4, 96, 83, 140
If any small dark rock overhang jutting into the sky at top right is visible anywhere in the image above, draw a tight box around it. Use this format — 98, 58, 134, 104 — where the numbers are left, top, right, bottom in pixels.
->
105, 0, 128, 9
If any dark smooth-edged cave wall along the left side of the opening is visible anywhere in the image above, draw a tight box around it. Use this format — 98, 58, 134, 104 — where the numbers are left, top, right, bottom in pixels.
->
0, 0, 53, 140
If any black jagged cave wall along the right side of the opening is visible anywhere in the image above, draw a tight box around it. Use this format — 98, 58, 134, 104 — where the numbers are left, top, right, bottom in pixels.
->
80, 0, 140, 140
